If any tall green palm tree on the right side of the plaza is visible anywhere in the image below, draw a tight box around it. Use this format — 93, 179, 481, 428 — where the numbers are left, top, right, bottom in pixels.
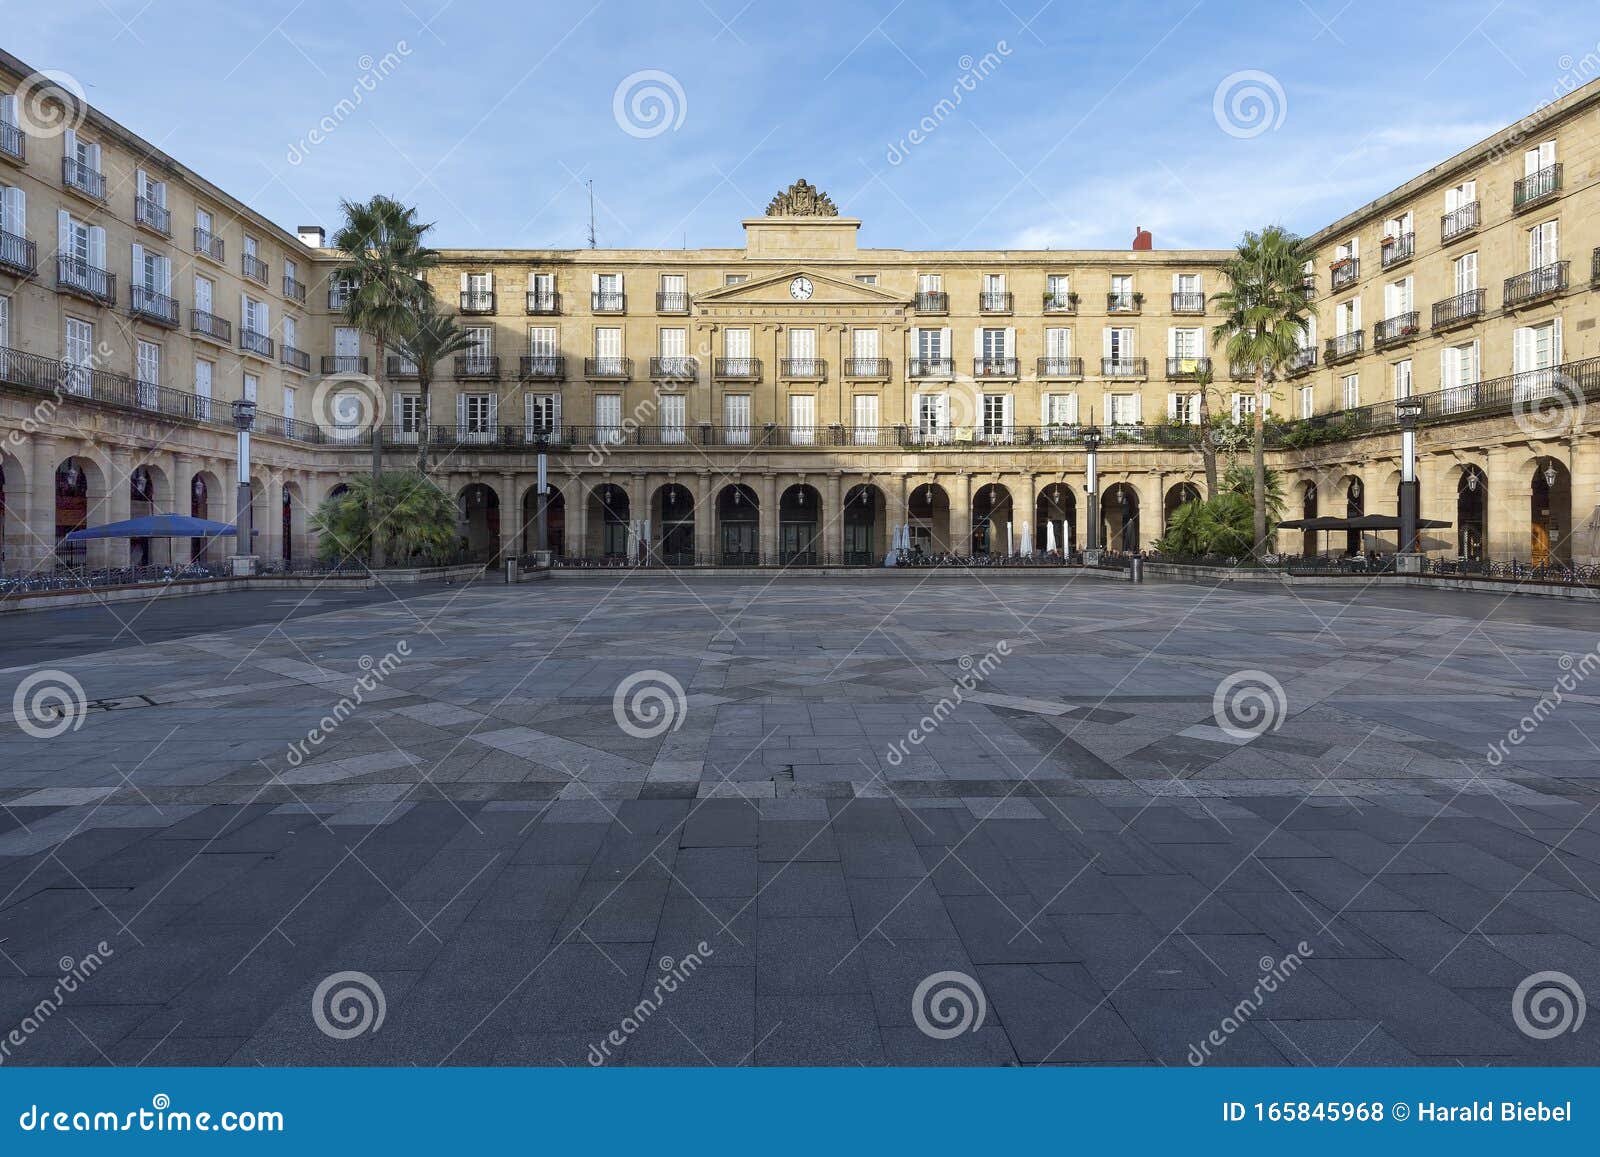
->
1211, 226, 1317, 554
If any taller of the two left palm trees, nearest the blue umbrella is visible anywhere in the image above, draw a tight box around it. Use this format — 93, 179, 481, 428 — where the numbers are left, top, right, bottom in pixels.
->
333, 194, 438, 566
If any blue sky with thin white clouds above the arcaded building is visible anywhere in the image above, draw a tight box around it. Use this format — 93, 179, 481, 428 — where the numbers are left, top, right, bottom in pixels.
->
15, 0, 1600, 248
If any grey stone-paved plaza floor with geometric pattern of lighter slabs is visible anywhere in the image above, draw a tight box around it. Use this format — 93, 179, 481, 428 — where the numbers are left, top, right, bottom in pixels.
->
0, 571, 1600, 1066
